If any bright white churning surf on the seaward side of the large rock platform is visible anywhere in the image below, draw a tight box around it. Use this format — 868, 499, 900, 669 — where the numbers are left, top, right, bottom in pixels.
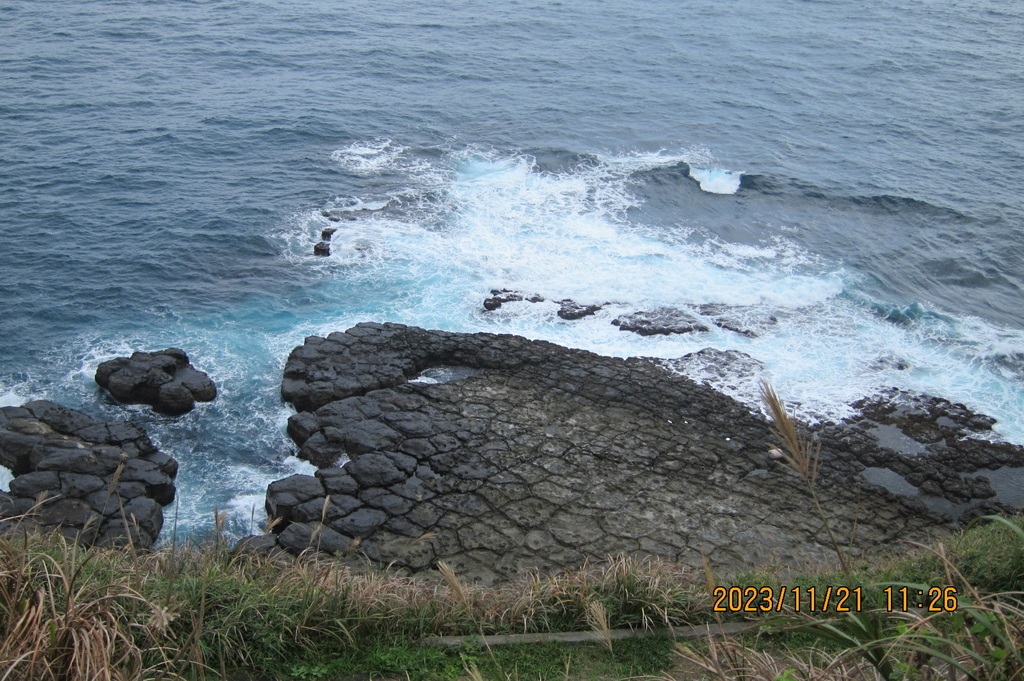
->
299, 145, 1024, 441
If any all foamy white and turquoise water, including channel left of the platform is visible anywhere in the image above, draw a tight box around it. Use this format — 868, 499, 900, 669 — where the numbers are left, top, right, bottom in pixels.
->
9, 143, 1024, 538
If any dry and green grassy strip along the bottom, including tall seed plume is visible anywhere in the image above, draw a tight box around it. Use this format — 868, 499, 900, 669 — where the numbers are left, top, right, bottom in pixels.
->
6, 382, 1024, 681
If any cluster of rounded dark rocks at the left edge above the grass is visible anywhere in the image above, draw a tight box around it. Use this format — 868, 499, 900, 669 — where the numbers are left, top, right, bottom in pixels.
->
0, 400, 178, 548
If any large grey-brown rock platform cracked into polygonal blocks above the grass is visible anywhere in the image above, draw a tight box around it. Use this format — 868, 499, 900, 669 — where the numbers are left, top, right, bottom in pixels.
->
251, 324, 1024, 583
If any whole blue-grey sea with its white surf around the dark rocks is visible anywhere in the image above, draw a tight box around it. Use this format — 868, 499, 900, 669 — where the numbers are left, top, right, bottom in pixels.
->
0, 0, 1024, 535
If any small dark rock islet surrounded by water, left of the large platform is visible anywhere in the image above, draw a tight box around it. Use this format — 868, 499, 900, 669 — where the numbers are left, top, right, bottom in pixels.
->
96, 347, 217, 416
